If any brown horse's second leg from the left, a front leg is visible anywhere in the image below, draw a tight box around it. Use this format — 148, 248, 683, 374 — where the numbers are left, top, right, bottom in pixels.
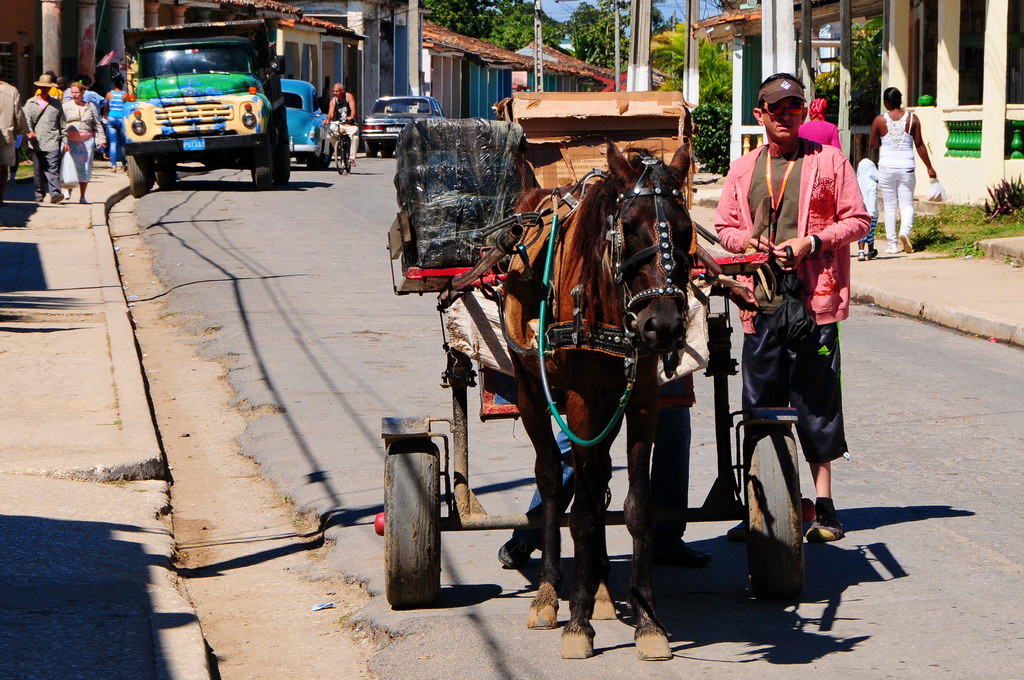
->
562, 393, 614, 658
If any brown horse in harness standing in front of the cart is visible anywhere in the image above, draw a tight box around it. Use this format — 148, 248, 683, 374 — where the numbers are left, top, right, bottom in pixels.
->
505, 144, 695, 660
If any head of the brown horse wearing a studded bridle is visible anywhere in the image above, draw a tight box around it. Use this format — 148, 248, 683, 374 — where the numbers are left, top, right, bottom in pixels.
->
607, 144, 693, 353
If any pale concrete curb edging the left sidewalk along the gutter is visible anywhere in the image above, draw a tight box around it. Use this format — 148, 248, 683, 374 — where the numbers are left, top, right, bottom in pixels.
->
92, 180, 211, 680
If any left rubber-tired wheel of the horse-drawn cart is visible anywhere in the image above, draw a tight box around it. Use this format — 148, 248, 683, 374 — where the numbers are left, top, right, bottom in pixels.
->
384, 437, 441, 609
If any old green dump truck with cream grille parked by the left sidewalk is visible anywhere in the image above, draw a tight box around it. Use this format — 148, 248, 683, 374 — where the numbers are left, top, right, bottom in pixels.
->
124, 20, 291, 198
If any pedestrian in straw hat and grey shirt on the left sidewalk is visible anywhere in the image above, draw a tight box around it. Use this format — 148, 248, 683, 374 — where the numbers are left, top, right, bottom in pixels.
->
24, 74, 63, 203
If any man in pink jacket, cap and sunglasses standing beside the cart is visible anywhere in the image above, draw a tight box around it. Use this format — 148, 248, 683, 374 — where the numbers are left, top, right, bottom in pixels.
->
715, 74, 870, 542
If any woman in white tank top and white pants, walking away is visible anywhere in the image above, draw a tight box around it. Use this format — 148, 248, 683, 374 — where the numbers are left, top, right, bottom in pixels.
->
868, 87, 936, 253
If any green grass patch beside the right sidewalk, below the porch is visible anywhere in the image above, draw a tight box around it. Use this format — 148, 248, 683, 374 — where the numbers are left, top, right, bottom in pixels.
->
913, 205, 1024, 257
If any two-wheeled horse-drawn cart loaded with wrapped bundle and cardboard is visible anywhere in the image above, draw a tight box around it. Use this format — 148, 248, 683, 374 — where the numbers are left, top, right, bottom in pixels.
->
378, 92, 804, 608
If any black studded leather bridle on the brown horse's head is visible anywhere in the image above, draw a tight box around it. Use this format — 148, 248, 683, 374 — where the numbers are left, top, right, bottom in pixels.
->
607, 151, 693, 323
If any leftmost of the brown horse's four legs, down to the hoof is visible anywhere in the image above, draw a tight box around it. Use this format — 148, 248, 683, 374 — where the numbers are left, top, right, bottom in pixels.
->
513, 357, 562, 630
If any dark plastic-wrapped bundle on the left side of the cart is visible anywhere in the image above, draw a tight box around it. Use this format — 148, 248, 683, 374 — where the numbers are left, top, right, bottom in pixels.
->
394, 118, 525, 268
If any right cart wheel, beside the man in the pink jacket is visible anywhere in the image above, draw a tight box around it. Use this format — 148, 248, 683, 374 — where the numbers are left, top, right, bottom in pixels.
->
746, 428, 804, 600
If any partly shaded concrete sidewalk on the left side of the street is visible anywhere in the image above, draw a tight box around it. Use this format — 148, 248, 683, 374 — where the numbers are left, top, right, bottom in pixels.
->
0, 168, 209, 680
